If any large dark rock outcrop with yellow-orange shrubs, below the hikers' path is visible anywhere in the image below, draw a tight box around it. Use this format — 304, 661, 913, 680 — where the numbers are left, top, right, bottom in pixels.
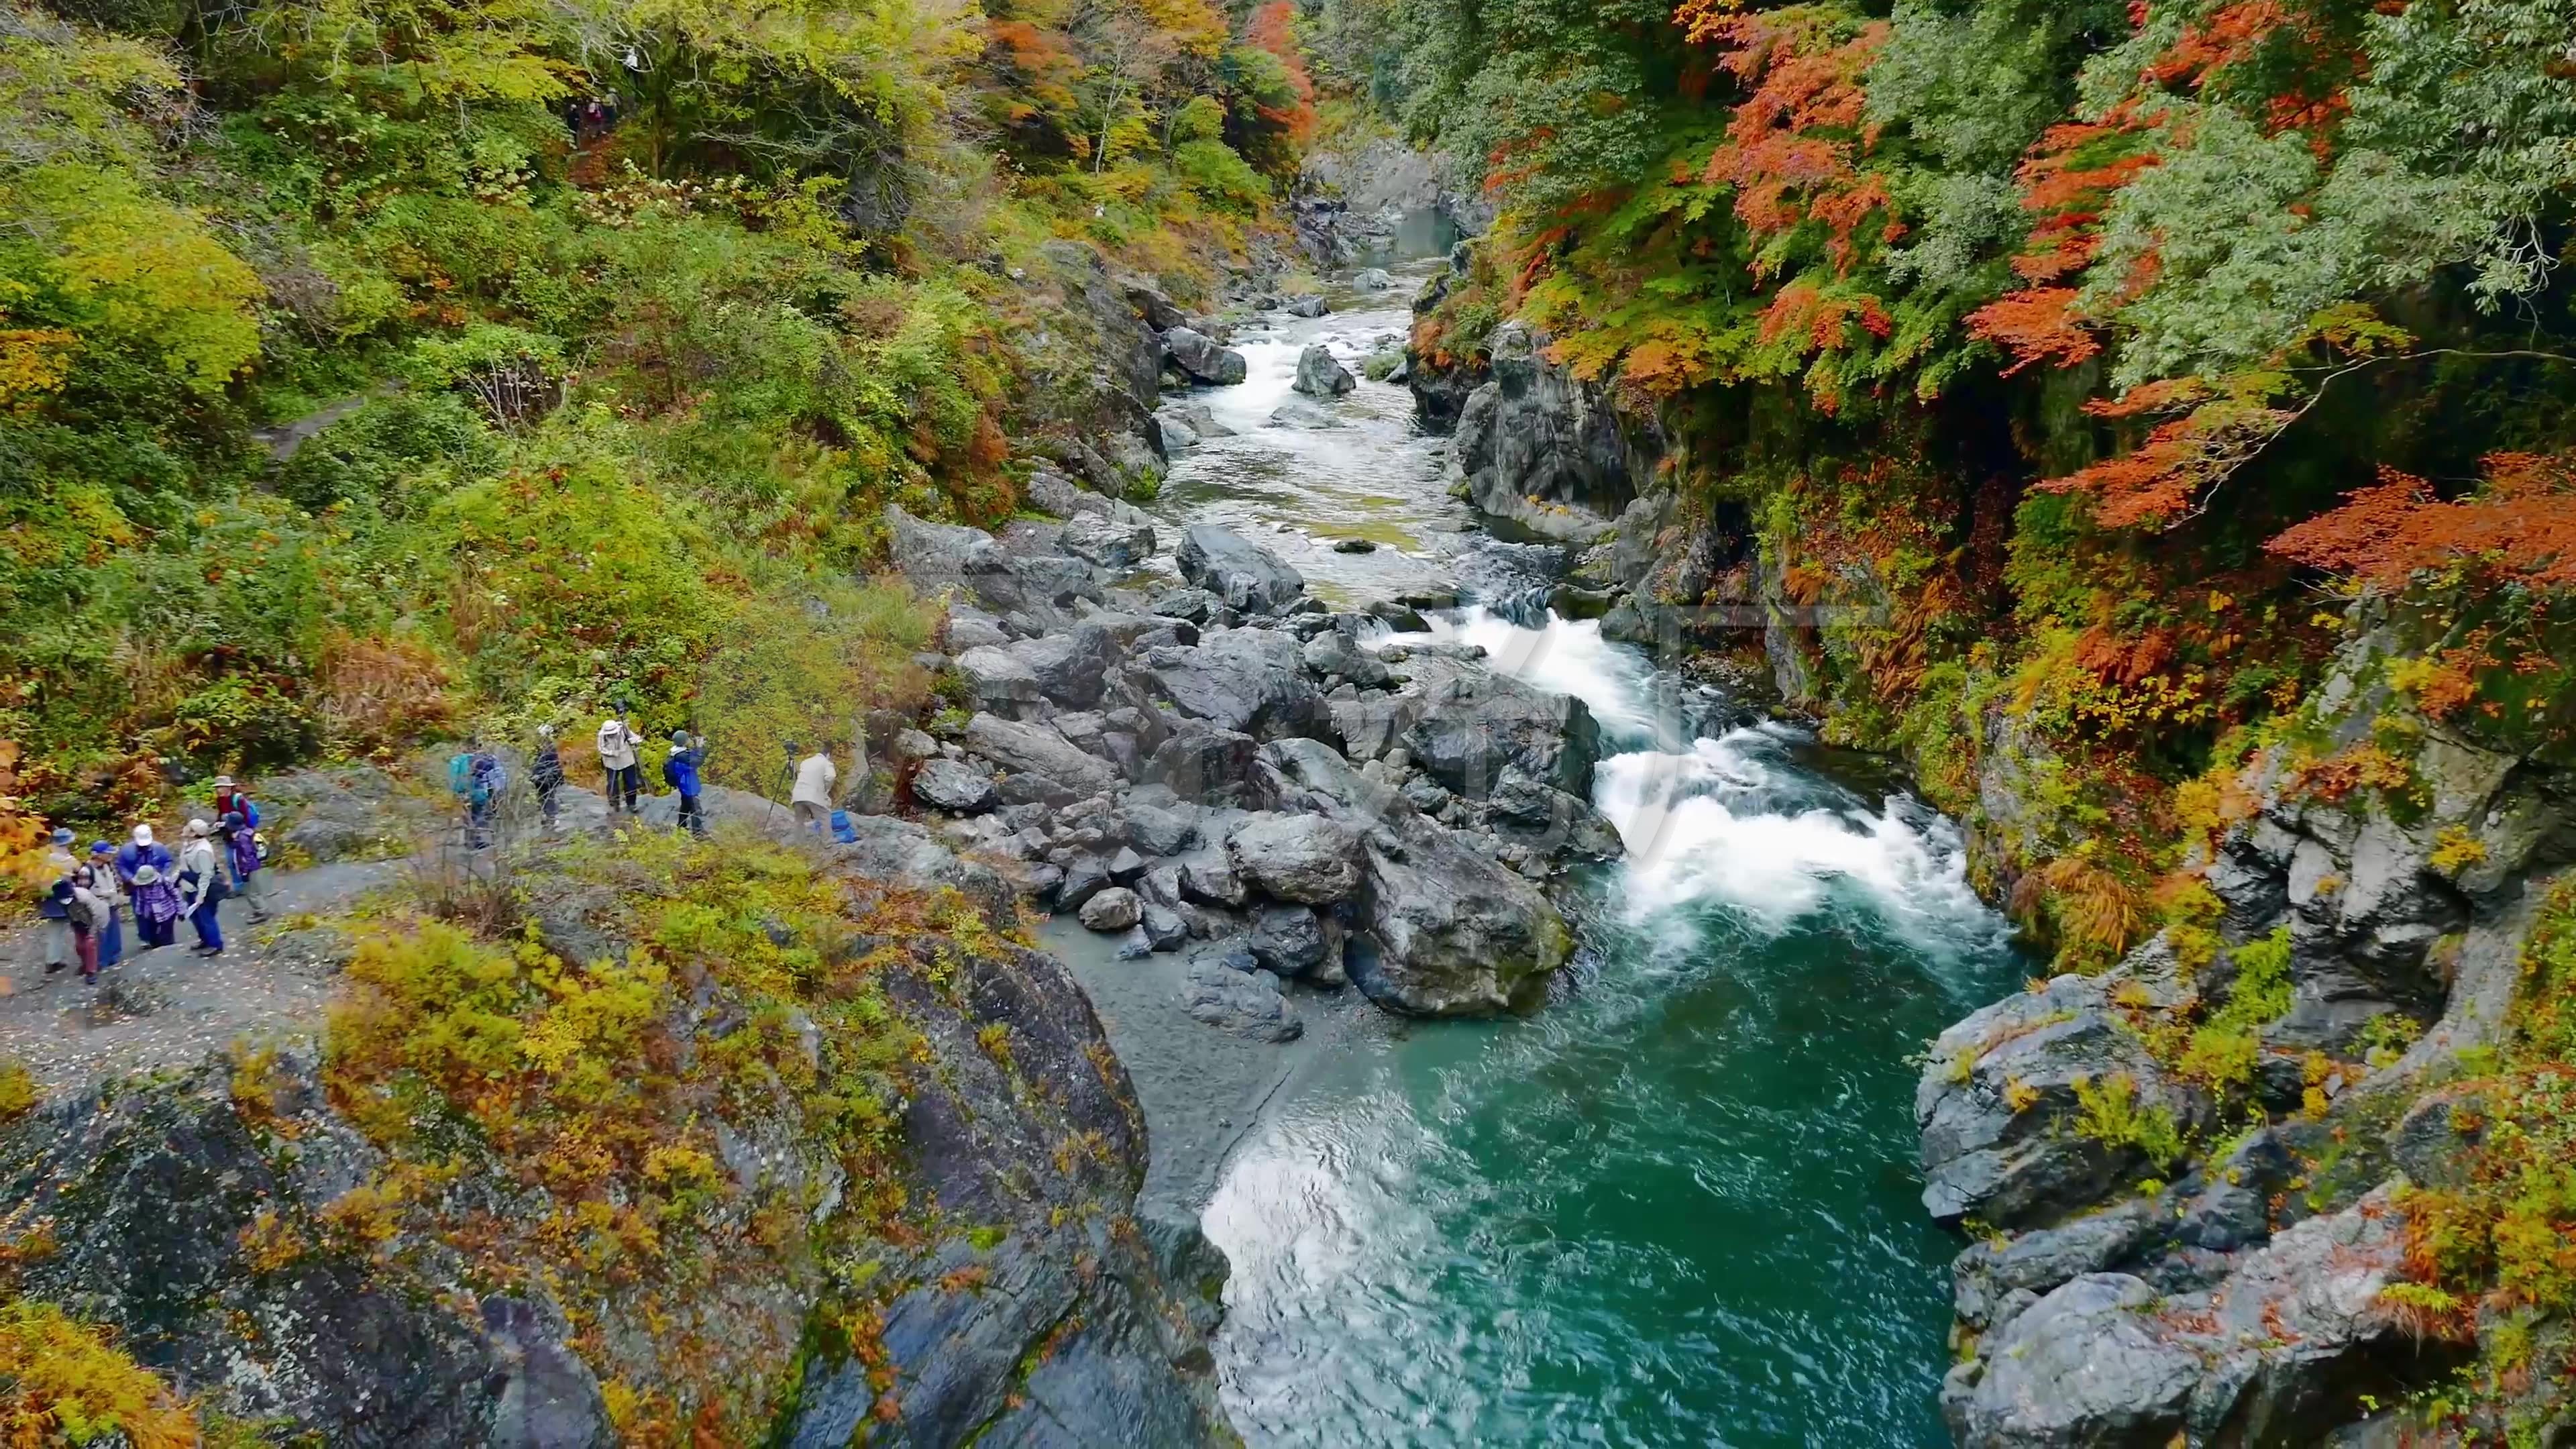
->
0, 822, 1232, 1449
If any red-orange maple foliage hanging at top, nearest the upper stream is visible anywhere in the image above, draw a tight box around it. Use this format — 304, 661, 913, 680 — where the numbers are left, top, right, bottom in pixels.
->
1674, 0, 1904, 273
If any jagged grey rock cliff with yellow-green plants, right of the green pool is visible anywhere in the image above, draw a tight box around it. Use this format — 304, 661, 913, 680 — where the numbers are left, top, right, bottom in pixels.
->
1917, 613, 2576, 1446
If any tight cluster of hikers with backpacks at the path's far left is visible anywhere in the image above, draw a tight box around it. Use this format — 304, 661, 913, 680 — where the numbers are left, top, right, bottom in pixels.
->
36, 776, 268, 985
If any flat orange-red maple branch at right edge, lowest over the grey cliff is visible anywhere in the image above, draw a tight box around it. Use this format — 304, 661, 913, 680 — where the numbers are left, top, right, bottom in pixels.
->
2267, 453, 2576, 588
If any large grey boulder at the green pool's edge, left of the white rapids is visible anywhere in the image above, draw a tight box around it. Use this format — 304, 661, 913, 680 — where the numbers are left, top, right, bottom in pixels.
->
1260, 740, 1574, 1016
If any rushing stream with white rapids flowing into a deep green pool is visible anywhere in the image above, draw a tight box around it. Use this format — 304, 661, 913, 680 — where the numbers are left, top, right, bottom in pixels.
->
1138, 262, 2020, 1446
